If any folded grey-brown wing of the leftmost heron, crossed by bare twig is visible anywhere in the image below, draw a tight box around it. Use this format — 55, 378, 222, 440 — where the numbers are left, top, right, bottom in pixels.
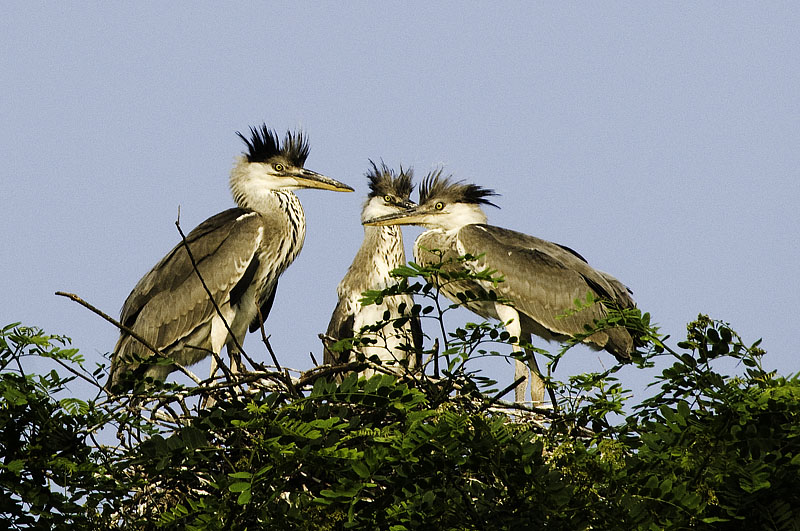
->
120, 208, 263, 356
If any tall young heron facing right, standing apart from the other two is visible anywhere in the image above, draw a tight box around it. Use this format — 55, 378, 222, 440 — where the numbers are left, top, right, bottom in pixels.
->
108, 125, 353, 389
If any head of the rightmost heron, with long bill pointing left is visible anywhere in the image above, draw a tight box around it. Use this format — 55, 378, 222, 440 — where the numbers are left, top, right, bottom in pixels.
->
363, 170, 497, 230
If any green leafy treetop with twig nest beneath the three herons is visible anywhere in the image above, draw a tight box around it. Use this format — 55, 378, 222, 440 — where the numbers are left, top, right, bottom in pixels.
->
0, 256, 800, 530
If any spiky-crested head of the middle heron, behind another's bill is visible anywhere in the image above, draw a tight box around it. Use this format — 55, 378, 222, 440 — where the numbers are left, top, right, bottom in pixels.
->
361, 161, 416, 221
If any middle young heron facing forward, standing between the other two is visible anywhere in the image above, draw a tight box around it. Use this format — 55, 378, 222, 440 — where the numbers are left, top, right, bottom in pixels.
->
325, 161, 422, 376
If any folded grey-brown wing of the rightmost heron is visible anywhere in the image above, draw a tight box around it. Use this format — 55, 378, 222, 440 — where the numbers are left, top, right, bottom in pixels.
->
457, 224, 633, 346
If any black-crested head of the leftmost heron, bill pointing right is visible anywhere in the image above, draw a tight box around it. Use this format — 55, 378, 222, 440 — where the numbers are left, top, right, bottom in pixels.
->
231, 125, 353, 207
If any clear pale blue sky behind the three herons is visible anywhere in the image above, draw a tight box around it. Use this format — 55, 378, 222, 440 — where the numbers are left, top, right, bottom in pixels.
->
0, 1, 800, 404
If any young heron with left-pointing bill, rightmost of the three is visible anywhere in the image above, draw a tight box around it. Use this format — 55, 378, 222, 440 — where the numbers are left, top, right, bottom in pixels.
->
365, 171, 635, 402
